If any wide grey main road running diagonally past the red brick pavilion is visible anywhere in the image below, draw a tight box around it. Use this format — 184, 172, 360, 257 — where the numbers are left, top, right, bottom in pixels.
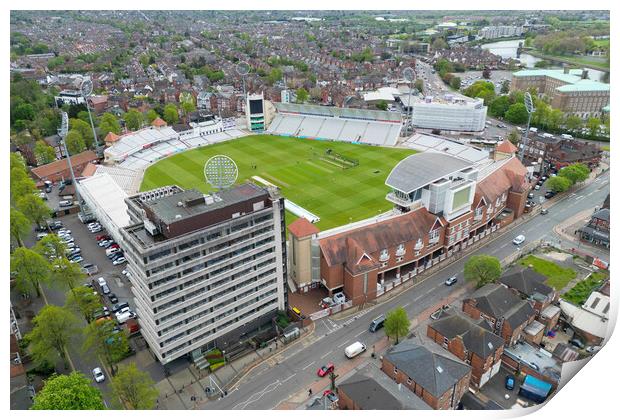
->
202, 172, 609, 410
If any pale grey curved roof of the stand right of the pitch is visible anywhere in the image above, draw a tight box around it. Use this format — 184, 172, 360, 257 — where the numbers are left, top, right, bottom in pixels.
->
385, 152, 474, 193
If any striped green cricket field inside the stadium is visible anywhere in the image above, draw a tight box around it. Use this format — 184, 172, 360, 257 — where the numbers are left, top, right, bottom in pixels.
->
141, 135, 414, 230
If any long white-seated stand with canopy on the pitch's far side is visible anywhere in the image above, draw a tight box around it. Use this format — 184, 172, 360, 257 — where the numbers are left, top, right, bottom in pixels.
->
267, 103, 402, 146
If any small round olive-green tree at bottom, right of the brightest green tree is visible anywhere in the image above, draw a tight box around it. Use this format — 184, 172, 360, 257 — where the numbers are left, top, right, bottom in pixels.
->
112, 363, 159, 410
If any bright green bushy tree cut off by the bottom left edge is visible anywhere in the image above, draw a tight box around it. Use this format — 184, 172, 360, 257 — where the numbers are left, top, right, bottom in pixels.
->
30, 372, 105, 410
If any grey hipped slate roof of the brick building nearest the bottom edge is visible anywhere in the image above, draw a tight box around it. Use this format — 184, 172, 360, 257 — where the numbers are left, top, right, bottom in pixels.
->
384, 340, 471, 397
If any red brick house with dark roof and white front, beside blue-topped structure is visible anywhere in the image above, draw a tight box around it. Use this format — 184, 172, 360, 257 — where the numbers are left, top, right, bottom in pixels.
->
426, 314, 504, 388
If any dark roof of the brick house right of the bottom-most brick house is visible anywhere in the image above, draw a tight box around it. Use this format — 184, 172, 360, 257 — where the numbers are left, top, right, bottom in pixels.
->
429, 314, 504, 359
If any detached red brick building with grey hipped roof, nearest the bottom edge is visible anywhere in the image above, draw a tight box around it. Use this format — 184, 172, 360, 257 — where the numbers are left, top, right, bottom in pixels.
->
381, 340, 471, 410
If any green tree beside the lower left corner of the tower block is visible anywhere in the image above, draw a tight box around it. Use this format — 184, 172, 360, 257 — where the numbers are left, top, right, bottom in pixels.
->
82, 318, 129, 373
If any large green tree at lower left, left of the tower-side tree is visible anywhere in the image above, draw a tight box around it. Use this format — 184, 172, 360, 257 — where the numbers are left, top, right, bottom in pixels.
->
26, 305, 78, 366
